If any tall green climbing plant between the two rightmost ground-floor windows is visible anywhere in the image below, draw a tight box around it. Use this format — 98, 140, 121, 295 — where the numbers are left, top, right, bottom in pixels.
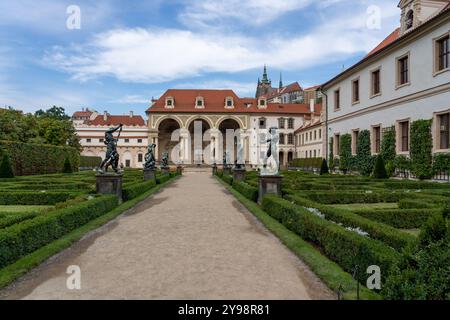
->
410, 120, 433, 179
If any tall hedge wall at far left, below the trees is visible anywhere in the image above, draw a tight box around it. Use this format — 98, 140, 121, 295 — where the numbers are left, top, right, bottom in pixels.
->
0, 140, 80, 176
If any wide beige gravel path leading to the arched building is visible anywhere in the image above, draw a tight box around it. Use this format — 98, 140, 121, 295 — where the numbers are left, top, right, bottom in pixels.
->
0, 172, 334, 299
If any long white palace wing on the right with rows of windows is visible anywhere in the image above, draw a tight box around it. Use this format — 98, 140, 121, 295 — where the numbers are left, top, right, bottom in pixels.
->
322, 0, 450, 160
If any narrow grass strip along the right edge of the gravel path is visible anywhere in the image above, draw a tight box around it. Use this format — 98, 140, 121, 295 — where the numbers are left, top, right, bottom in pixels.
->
217, 178, 381, 300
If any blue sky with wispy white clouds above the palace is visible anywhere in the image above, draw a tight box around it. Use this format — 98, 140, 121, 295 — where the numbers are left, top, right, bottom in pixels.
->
0, 0, 400, 115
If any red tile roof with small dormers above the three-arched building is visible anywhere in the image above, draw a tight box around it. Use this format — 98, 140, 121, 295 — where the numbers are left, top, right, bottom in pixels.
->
147, 89, 322, 114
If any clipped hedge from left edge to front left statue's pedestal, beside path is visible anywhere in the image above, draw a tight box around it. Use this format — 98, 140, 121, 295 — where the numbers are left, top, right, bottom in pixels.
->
0, 196, 118, 268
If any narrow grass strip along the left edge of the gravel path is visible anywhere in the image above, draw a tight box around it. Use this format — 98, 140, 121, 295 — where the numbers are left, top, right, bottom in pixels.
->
0, 176, 179, 289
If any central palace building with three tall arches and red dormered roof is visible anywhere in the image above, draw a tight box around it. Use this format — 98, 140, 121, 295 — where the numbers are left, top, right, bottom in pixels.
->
147, 89, 321, 167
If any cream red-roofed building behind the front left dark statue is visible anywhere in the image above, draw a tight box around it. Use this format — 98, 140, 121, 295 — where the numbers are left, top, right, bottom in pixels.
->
72, 109, 148, 168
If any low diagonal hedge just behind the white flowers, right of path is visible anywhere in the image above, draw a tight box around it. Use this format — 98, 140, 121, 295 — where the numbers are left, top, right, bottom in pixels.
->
286, 196, 416, 250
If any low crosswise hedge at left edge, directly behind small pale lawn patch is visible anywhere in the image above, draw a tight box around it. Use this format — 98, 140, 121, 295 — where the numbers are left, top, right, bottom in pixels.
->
0, 191, 77, 205
